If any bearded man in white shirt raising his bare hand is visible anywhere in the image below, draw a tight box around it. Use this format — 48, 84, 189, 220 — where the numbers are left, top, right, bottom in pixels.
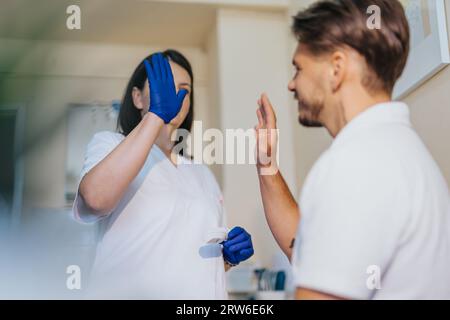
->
256, 0, 450, 299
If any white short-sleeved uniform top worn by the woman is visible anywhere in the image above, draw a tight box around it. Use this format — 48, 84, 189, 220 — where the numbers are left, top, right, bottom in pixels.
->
73, 132, 227, 299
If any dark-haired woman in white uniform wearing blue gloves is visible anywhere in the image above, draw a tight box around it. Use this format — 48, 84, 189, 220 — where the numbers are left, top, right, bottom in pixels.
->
74, 50, 253, 299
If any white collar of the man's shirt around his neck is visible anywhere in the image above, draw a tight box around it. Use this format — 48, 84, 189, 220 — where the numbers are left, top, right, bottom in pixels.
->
331, 102, 411, 148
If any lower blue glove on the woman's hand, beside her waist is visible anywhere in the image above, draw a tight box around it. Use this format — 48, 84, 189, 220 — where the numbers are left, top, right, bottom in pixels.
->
222, 227, 254, 265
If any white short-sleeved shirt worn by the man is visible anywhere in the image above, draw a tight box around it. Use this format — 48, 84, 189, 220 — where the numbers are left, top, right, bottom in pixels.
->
293, 102, 450, 299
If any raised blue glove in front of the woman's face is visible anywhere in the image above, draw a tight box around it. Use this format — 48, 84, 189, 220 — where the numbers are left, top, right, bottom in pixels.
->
144, 53, 188, 124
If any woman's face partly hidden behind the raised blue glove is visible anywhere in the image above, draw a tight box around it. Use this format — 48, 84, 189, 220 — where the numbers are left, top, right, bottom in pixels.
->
133, 60, 192, 128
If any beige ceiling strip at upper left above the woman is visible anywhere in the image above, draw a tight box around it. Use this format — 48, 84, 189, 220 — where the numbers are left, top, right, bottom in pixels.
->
0, 0, 215, 46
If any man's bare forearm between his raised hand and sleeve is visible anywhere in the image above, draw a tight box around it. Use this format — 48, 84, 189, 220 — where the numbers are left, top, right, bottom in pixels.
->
258, 171, 300, 259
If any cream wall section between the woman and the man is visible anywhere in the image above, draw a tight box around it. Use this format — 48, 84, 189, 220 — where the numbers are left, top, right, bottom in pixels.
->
217, 9, 296, 265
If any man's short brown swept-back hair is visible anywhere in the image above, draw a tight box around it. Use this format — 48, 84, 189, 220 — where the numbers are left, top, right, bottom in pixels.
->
292, 0, 410, 94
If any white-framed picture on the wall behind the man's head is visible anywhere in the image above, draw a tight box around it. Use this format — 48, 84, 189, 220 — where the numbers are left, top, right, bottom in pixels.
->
394, 0, 450, 100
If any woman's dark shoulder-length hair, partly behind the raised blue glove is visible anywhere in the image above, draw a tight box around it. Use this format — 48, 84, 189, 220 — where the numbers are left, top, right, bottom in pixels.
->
117, 49, 194, 152
